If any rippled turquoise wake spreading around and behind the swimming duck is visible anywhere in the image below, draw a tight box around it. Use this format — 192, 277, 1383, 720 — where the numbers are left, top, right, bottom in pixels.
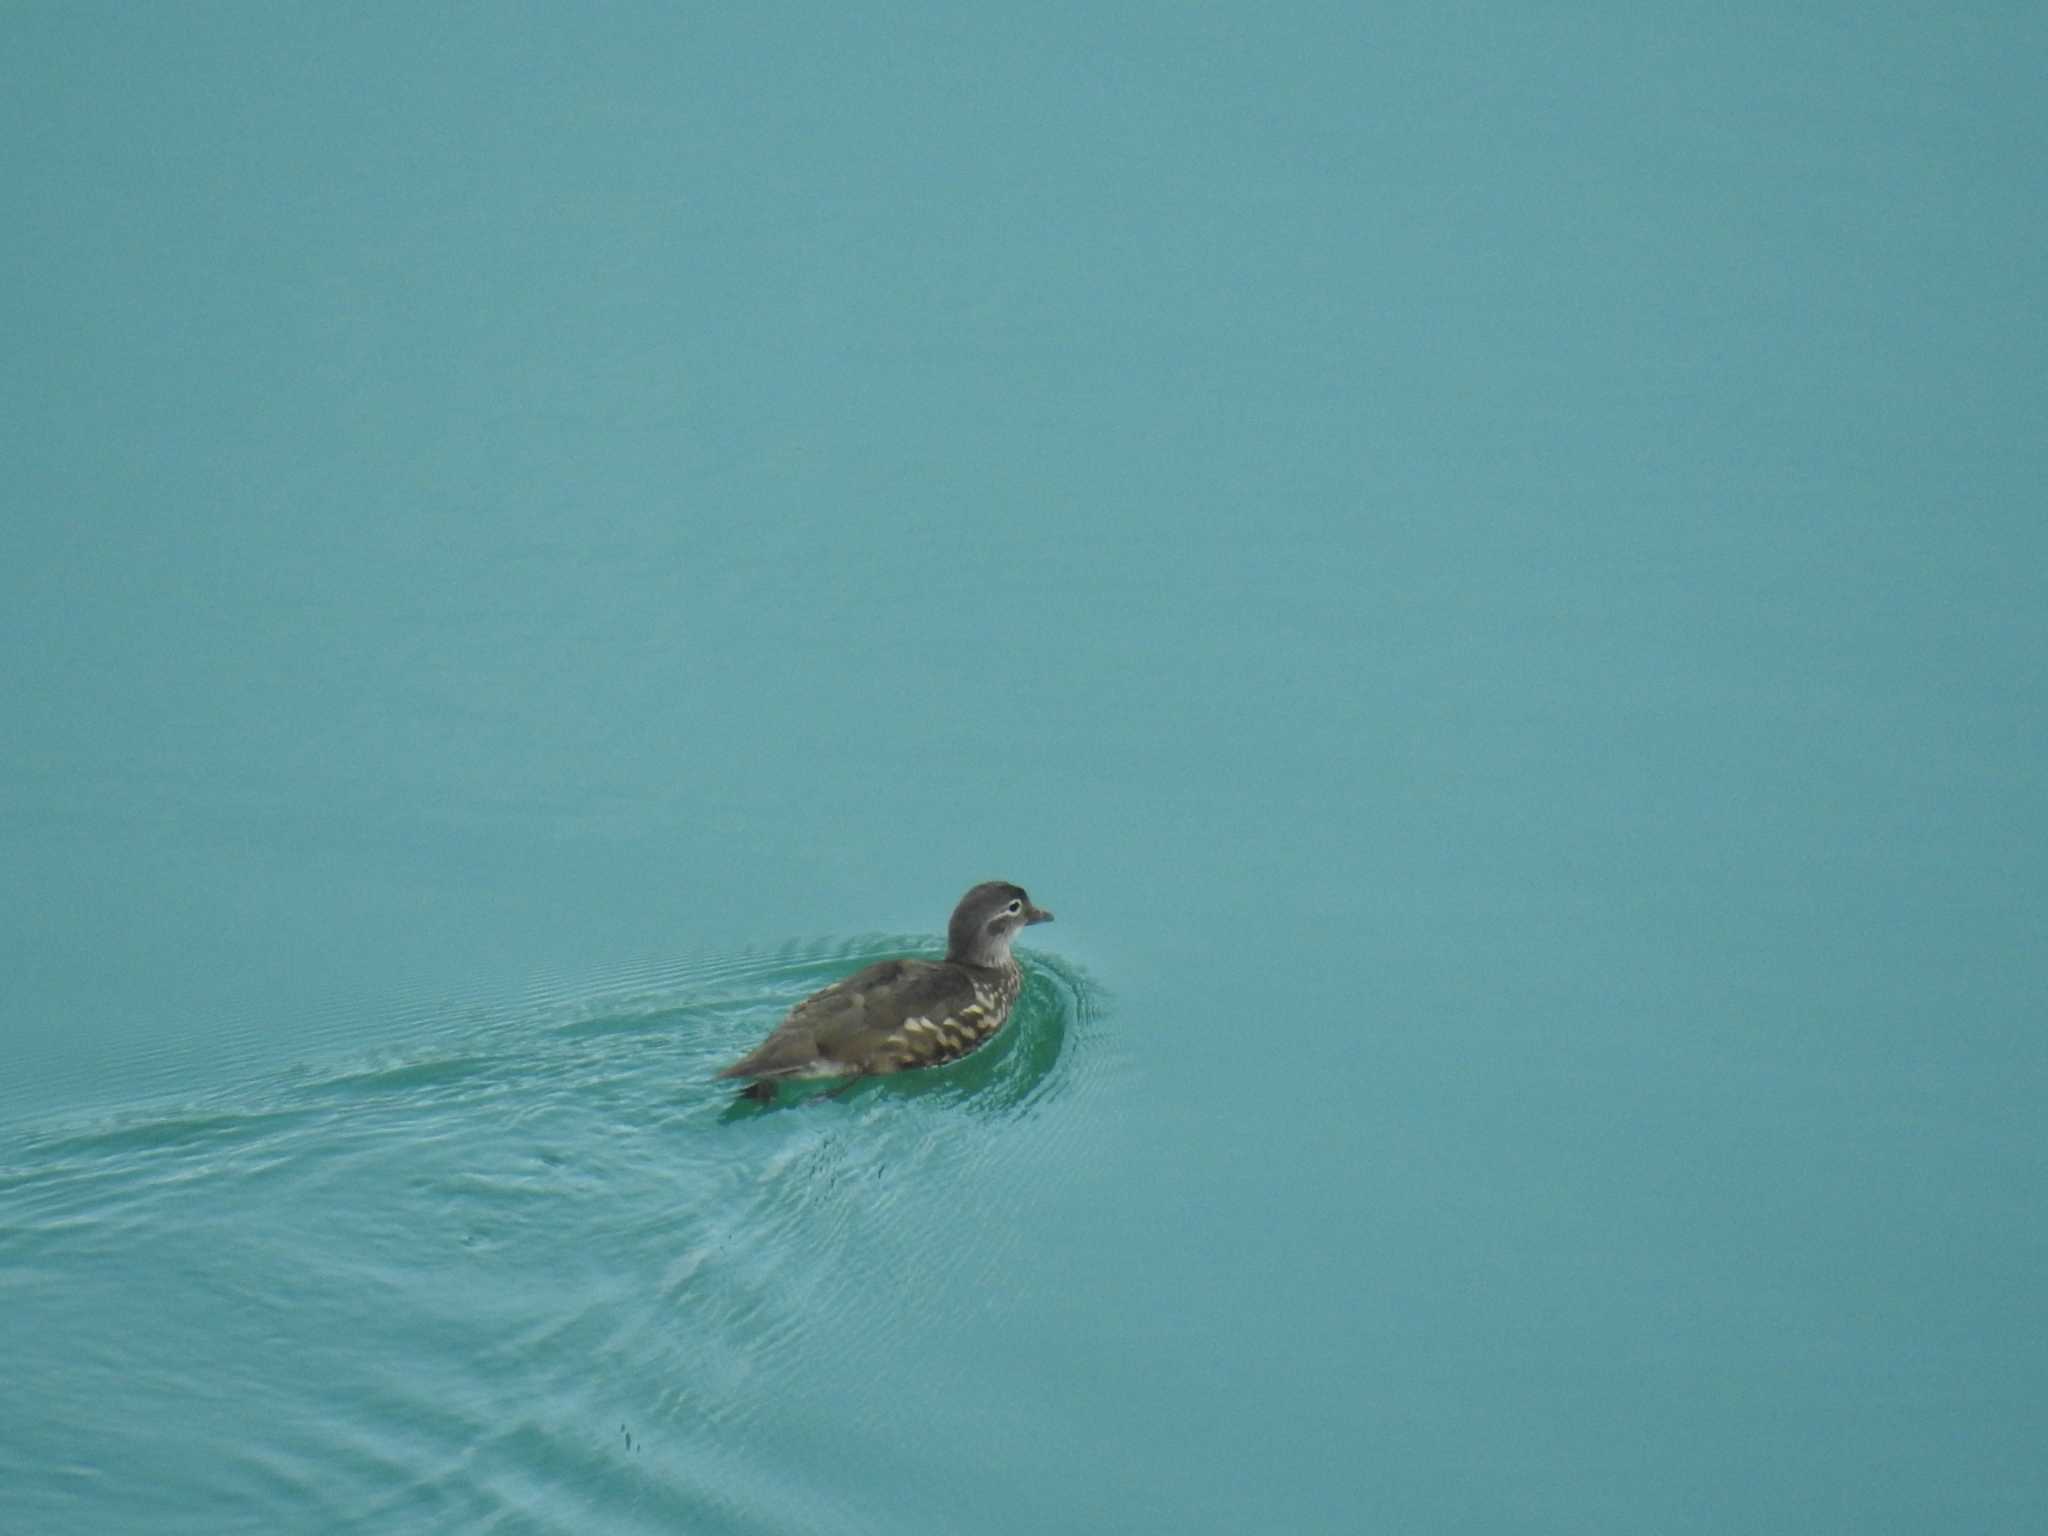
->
0, 936, 1106, 1532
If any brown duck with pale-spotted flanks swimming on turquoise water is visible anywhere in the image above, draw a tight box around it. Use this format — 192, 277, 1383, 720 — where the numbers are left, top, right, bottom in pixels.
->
719, 881, 1053, 1100
